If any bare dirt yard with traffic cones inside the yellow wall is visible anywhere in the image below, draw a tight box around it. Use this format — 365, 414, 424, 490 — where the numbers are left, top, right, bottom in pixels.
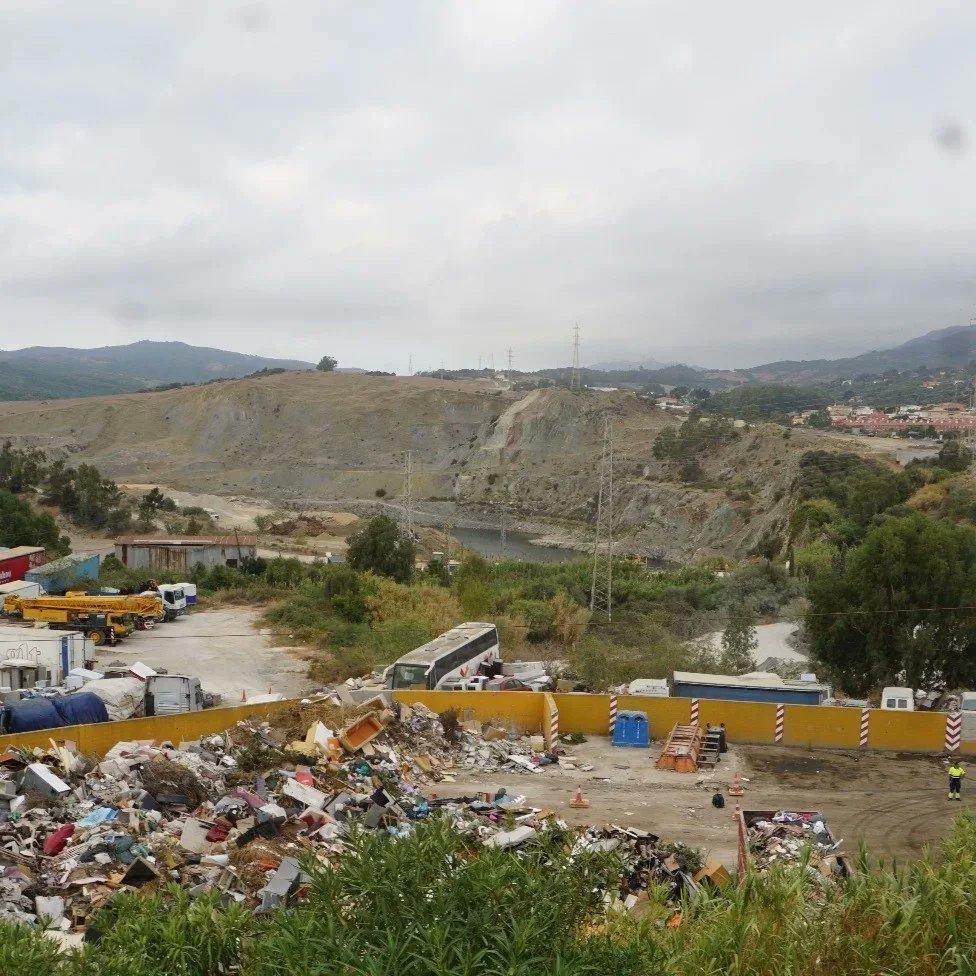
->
437, 739, 976, 865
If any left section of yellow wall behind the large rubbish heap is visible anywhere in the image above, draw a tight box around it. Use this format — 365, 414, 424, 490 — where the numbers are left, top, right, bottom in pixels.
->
0, 702, 282, 759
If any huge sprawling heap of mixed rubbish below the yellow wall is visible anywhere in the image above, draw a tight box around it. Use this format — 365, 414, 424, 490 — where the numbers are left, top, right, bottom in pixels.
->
0, 697, 727, 934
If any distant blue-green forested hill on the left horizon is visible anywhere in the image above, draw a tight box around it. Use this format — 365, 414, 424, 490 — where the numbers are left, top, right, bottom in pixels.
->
0, 340, 312, 400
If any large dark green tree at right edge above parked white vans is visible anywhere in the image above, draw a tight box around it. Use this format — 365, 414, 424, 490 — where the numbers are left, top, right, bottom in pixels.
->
807, 514, 976, 694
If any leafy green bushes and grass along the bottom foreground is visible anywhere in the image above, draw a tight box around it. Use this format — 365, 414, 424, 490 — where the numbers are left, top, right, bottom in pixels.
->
0, 816, 976, 976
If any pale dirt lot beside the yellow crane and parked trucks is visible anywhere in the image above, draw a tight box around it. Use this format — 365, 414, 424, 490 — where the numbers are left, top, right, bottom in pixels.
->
97, 607, 311, 705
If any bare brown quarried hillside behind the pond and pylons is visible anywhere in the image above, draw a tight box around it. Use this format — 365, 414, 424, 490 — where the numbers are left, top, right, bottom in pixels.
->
0, 372, 876, 560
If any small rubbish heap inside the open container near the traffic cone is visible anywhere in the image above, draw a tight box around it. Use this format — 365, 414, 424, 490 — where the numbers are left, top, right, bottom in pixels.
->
745, 810, 848, 877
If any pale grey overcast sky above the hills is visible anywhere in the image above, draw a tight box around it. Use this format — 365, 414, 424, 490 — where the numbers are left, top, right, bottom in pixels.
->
0, 0, 976, 372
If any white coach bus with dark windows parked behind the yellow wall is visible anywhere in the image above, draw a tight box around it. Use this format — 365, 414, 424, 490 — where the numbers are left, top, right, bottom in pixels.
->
387, 623, 499, 691
